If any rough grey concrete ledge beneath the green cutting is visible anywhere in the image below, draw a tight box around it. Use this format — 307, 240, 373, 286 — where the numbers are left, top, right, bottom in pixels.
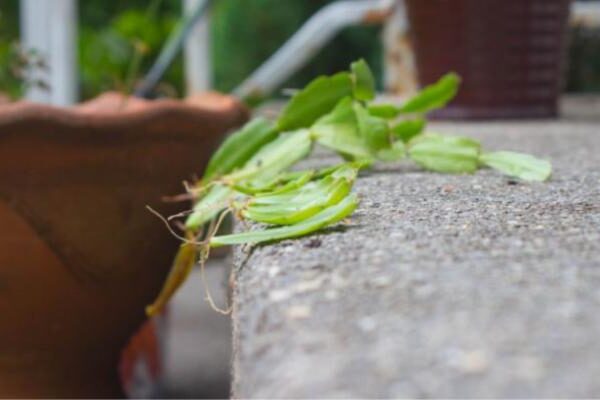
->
233, 120, 600, 398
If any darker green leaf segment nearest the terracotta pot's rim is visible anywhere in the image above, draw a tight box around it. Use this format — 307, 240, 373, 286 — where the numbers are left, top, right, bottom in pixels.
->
204, 117, 277, 180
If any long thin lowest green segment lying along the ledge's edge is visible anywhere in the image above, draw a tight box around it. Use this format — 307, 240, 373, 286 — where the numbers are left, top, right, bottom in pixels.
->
210, 195, 358, 247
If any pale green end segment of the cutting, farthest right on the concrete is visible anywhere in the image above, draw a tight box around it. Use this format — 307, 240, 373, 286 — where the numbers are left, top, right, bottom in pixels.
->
479, 151, 552, 182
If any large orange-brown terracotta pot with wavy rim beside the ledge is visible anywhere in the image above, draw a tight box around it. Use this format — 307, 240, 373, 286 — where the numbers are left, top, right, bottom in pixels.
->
0, 93, 247, 398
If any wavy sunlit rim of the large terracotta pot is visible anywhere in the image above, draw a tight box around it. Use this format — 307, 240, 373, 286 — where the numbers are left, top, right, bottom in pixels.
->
0, 92, 249, 139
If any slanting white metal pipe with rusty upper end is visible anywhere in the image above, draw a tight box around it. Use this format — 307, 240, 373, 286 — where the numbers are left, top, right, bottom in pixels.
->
233, 0, 396, 98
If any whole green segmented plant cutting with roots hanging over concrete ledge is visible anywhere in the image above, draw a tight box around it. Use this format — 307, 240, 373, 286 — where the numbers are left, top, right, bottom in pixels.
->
146, 60, 552, 315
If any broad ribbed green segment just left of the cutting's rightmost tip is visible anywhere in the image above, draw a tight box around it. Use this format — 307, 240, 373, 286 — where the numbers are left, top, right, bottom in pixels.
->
408, 133, 480, 174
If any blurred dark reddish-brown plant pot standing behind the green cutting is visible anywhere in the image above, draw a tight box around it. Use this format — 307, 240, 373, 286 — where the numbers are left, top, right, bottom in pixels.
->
406, 0, 570, 118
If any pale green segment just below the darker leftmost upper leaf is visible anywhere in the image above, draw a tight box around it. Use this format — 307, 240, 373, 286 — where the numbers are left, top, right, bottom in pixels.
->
223, 129, 312, 185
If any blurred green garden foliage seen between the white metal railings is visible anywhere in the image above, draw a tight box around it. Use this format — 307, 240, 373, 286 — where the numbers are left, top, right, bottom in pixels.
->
0, 0, 600, 104
